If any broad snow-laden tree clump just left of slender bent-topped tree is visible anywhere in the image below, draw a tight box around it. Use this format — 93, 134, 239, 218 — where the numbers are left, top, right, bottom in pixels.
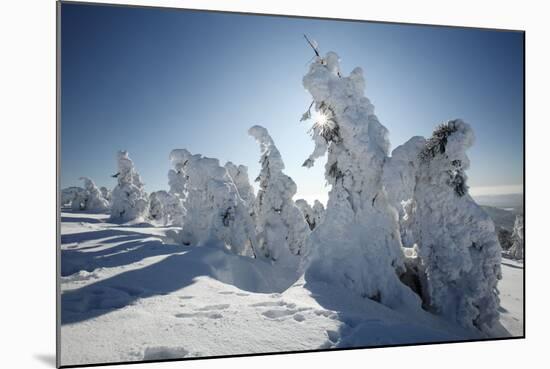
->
170, 149, 256, 256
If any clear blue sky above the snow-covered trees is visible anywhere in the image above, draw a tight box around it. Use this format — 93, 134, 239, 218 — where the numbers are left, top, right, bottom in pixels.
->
61, 4, 523, 201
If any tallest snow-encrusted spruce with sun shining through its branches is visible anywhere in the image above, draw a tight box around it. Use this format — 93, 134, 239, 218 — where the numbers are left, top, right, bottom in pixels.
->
302, 50, 420, 309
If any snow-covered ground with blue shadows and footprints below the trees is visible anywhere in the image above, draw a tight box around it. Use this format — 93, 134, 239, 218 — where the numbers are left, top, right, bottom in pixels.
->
61, 210, 523, 365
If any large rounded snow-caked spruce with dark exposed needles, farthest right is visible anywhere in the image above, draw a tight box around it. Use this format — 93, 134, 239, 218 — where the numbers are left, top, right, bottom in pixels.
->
413, 120, 501, 330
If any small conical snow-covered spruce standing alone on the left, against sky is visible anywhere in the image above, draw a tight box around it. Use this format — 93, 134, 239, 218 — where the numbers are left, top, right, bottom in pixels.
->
111, 151, 149, 222
